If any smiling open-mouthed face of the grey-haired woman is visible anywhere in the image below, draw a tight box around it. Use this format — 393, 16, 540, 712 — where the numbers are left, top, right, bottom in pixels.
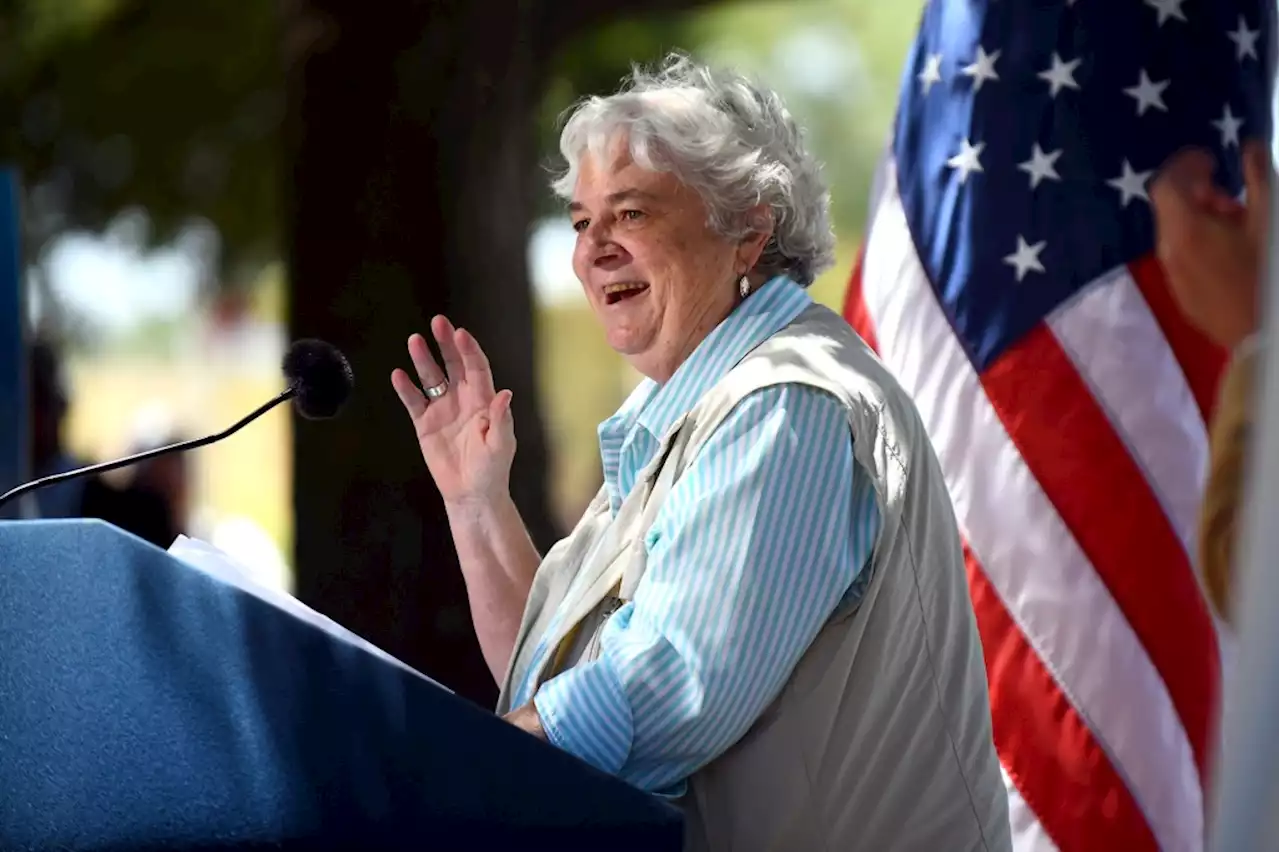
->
570, 139, 767, 383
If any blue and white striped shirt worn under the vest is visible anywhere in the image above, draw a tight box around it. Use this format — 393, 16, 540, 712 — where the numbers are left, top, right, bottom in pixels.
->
515, 278, 881, 794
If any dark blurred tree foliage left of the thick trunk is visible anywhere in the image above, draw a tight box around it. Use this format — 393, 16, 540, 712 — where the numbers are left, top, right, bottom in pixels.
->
0, 0, 284, 279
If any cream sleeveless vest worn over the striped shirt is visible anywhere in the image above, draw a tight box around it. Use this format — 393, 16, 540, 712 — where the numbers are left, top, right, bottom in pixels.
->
498, 306, 1010, 852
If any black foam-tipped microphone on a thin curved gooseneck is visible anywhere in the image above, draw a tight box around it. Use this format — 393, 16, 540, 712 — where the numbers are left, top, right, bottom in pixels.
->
0, 340, 356, 507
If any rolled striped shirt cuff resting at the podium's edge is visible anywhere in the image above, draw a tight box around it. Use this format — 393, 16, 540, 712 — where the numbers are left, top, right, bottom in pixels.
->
534, 659, 635, 775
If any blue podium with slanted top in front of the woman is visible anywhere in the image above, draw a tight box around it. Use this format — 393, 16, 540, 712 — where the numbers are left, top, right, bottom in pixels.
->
0, 521, 682, 852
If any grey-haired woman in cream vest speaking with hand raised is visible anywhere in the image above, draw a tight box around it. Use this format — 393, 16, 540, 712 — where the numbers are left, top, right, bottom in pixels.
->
392, 56, 1010, 852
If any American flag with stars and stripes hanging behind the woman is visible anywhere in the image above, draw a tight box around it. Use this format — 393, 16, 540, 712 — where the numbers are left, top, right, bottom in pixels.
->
845, 0, 1275, 852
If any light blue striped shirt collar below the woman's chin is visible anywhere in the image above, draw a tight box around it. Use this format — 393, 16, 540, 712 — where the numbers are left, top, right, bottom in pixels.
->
614, 275, 813, 440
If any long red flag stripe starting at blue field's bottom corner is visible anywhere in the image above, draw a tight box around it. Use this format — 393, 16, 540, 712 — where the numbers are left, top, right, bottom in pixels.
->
980, 324, 1219, 782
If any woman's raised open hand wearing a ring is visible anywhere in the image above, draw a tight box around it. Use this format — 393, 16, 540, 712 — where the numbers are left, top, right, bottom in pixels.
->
392, 316, 516, 505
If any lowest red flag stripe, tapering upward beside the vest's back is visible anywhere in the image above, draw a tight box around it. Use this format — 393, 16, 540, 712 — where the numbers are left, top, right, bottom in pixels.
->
964, 544, 1158, 852
